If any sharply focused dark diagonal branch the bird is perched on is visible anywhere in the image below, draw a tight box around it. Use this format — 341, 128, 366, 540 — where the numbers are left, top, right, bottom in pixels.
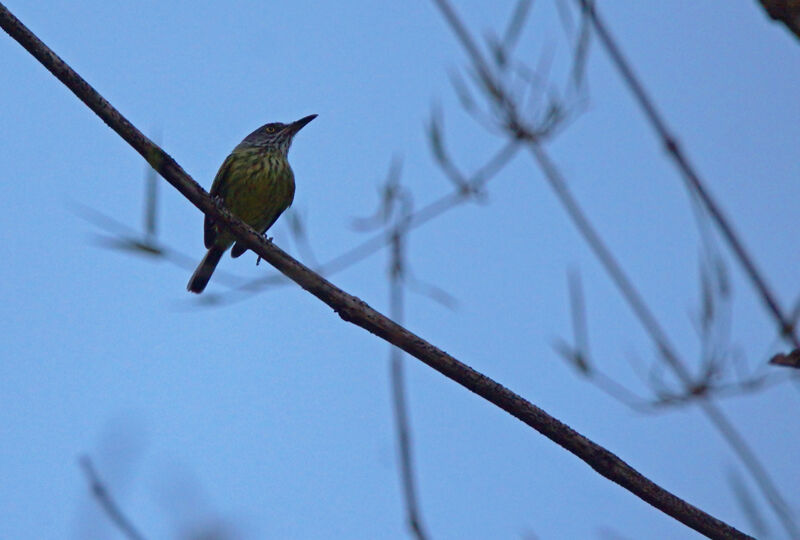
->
0, 4, 750, 538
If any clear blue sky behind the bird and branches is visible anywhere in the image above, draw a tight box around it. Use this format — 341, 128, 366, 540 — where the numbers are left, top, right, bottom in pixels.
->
0, 0, 800, 539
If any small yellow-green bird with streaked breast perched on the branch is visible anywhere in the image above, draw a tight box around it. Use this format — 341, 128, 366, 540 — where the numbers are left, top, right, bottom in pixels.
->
186, 114, 317, 294
